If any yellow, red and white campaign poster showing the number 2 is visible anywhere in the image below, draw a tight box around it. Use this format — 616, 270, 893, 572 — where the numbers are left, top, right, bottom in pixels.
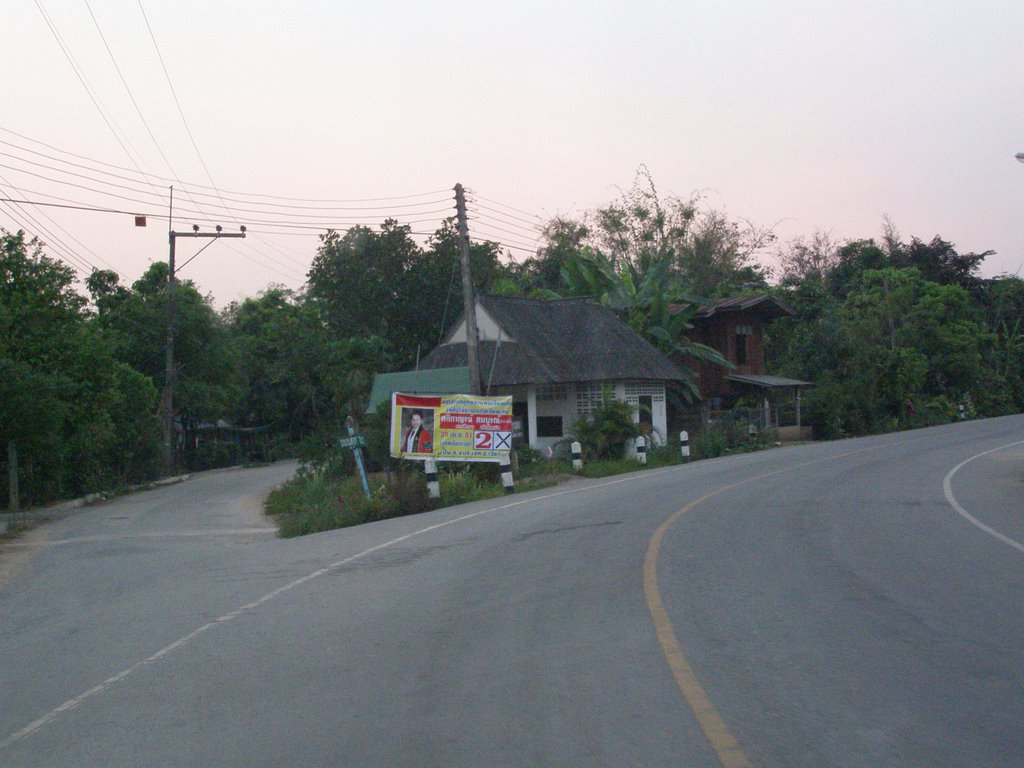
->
391, 392, 512, 462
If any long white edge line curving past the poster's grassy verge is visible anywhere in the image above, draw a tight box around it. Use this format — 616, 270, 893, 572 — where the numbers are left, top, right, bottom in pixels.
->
0, 464, 688, 750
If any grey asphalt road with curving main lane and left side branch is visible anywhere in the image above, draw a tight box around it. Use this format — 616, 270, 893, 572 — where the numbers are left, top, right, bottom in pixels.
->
0, 416, 1024, 768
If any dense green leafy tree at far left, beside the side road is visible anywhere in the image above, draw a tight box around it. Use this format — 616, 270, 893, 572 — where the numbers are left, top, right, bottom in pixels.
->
0, 232, 159, 503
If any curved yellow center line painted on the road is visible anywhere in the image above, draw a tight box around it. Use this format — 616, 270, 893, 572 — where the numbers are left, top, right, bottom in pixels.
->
643, 440, 909, 768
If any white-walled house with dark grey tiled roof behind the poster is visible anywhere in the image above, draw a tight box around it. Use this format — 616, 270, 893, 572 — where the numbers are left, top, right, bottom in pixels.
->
370, 294, 686, 450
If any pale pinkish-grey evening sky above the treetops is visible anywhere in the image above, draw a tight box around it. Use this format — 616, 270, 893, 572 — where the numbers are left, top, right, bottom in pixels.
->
0, 0, 1024, 306
